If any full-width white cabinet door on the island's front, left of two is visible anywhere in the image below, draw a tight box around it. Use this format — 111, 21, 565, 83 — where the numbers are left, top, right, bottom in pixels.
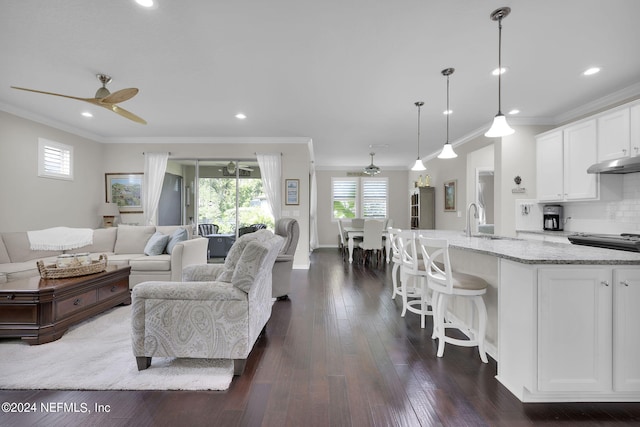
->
537, 266, 613, 392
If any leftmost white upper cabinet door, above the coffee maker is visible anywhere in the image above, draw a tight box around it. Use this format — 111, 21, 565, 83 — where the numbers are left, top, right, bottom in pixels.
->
536, 131, 563, 201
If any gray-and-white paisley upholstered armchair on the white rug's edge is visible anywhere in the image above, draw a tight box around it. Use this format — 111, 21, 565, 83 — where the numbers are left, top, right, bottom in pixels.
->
131, 230, 284, 375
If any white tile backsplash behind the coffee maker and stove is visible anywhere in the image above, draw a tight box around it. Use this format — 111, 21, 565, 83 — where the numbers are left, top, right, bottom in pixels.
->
515, 173, 640, 234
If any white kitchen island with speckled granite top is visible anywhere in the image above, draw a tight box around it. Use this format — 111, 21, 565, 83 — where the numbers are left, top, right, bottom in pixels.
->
419, 230, 640, 402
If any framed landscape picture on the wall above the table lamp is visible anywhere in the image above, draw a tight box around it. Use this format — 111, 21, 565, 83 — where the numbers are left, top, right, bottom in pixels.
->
104, 172, 144, 213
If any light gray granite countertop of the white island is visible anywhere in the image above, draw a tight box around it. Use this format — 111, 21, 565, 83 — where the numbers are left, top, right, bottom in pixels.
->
419, 230, 640, 265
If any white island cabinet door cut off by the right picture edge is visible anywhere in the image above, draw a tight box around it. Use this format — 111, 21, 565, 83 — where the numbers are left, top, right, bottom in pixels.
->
613, 268, 640, 391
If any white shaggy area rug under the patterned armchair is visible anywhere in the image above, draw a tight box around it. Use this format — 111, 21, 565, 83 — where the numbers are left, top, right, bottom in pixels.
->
0, 306, 233, 390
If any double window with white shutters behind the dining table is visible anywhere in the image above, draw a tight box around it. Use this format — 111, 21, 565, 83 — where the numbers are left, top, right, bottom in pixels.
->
331, 178, 389, 220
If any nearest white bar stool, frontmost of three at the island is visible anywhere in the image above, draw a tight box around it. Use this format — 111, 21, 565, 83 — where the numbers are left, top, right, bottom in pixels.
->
420, 236, 488, 363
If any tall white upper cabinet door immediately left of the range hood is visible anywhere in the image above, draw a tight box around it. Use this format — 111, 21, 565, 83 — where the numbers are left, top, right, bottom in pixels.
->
563, 120, 598, 200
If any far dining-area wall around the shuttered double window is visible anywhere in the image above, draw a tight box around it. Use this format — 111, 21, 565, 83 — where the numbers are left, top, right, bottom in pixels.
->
316, 168, 410, 247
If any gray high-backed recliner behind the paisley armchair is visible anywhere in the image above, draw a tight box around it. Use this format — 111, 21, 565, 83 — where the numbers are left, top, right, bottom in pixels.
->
273, 218, 300, 300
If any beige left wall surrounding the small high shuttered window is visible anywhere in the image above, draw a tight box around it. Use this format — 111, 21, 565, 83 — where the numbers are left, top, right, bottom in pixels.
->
0, 111, 105, 232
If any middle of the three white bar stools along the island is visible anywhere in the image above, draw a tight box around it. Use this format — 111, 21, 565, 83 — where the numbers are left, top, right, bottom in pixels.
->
398, 231, 433, 328
